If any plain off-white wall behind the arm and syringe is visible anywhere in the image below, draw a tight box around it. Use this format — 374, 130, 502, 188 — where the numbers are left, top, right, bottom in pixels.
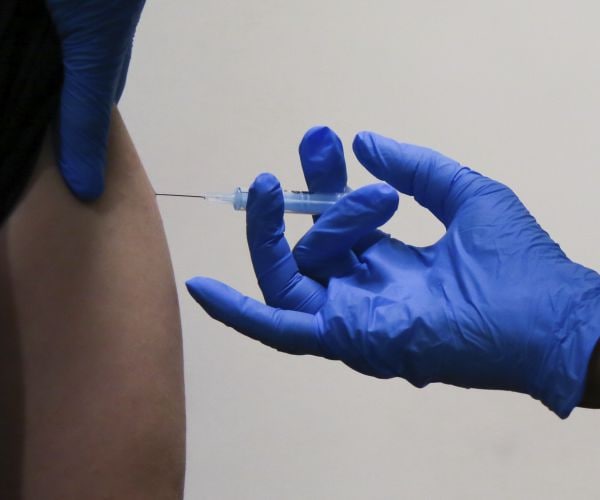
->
122, 0, 600, 500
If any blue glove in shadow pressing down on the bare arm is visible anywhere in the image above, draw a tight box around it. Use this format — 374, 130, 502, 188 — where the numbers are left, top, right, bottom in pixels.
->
47, 0, 145, 200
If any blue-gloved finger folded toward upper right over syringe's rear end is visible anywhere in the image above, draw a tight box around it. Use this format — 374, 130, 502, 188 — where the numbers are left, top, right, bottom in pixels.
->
294, 184, 398, 281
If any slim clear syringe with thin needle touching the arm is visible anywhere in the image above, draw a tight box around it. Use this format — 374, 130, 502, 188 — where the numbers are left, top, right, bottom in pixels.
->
156, 188, 347, 215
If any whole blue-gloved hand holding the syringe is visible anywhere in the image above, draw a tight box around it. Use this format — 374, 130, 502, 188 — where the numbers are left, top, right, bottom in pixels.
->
188, 129, 600, 418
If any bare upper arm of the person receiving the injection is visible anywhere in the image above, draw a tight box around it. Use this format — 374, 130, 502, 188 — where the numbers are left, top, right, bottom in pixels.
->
0, 107, 185, 500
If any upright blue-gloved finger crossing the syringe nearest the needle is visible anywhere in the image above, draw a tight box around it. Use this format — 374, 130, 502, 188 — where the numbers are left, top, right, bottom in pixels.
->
246, 174, 325, 313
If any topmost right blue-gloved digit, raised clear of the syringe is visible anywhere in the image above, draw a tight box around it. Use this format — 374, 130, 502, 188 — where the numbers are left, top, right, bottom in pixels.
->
352, 132, 489, 226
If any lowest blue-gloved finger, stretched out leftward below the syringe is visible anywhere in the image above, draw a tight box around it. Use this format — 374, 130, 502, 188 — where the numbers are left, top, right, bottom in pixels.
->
186, 277, 331, 358
